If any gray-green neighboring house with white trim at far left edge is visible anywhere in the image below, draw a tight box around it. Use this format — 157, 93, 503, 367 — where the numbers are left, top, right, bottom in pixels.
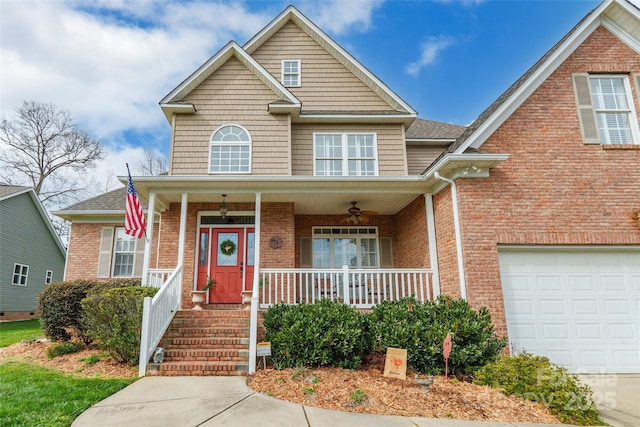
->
0, 185, 66, 320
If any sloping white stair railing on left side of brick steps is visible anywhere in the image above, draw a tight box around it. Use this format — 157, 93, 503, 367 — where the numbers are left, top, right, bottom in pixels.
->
138, 265, 182, 377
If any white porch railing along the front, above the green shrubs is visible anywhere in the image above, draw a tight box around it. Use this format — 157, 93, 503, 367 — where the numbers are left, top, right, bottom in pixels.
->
259, 266, 433, 308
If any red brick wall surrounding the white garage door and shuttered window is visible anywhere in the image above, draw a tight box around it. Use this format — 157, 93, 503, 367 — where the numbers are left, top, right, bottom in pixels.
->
434, 28, 640, 340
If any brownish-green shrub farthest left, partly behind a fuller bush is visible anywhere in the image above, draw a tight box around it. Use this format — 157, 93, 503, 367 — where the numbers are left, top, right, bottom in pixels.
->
37, 279, 140, 344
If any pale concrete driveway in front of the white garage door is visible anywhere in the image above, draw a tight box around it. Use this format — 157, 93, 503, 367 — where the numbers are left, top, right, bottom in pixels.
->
580, 374, 640, 427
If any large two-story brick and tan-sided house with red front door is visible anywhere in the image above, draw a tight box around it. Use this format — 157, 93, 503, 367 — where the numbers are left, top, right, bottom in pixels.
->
58, 0, 640, 372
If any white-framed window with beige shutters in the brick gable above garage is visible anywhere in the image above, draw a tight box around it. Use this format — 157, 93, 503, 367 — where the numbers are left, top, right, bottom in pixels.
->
589, 75, 639, 144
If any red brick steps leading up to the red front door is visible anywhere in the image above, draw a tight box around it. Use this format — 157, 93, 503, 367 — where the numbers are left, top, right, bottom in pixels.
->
147, 304, 249, 376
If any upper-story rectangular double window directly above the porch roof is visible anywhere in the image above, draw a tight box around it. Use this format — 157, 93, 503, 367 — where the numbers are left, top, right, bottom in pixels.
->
313, 133, 378, 176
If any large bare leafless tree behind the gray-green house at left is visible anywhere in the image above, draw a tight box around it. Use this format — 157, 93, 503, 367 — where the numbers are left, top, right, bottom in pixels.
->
0, 101, 103, 206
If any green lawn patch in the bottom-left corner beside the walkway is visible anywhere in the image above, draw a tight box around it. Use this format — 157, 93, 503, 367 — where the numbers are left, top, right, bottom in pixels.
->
0, 361, 134, 427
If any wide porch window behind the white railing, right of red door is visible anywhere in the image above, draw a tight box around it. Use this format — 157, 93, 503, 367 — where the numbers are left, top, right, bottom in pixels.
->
312, 227, 380, 268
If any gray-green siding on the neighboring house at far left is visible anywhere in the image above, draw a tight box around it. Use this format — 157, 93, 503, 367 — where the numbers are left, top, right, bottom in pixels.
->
0, 193, 64, 312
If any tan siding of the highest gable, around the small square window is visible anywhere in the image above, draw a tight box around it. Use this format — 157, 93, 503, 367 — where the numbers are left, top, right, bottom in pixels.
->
252, 22, 394, 111
